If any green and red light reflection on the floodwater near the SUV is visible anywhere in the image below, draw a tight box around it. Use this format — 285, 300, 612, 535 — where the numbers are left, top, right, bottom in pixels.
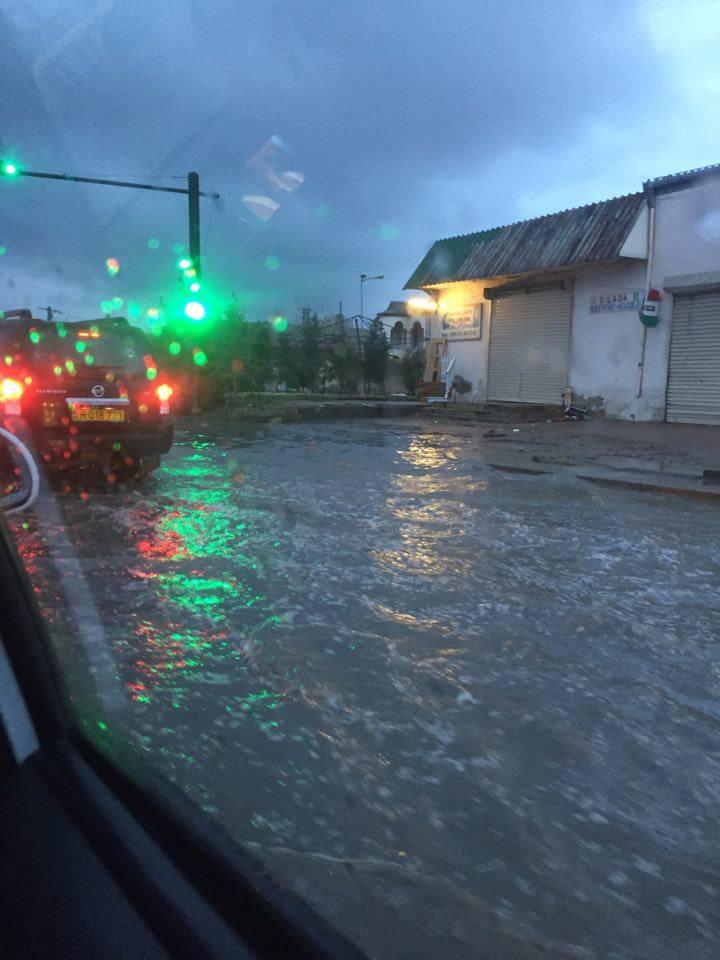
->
122, 438, 287, 732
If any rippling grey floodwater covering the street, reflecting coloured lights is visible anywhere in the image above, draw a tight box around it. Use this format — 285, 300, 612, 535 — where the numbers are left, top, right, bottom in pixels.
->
9, 421, 720, 960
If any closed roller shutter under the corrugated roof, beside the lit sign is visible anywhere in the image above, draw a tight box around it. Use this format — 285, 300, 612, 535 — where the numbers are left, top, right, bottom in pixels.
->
488, 290, 572, 404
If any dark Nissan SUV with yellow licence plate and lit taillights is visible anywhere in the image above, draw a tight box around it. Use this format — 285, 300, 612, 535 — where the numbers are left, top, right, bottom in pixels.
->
0, 310, 173, 476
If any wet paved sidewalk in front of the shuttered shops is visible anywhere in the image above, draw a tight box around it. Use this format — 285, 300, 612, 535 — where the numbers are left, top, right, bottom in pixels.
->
478, 420, 720, 498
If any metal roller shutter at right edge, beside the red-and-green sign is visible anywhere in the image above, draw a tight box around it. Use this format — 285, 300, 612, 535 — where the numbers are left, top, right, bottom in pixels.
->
667, 290, 720, 424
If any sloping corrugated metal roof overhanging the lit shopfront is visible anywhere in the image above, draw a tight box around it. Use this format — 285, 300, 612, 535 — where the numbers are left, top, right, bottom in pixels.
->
405, 193, 645, 290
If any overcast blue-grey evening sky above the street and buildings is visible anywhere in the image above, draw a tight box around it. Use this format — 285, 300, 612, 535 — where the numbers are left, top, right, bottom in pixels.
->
0, 0, 720, 319
